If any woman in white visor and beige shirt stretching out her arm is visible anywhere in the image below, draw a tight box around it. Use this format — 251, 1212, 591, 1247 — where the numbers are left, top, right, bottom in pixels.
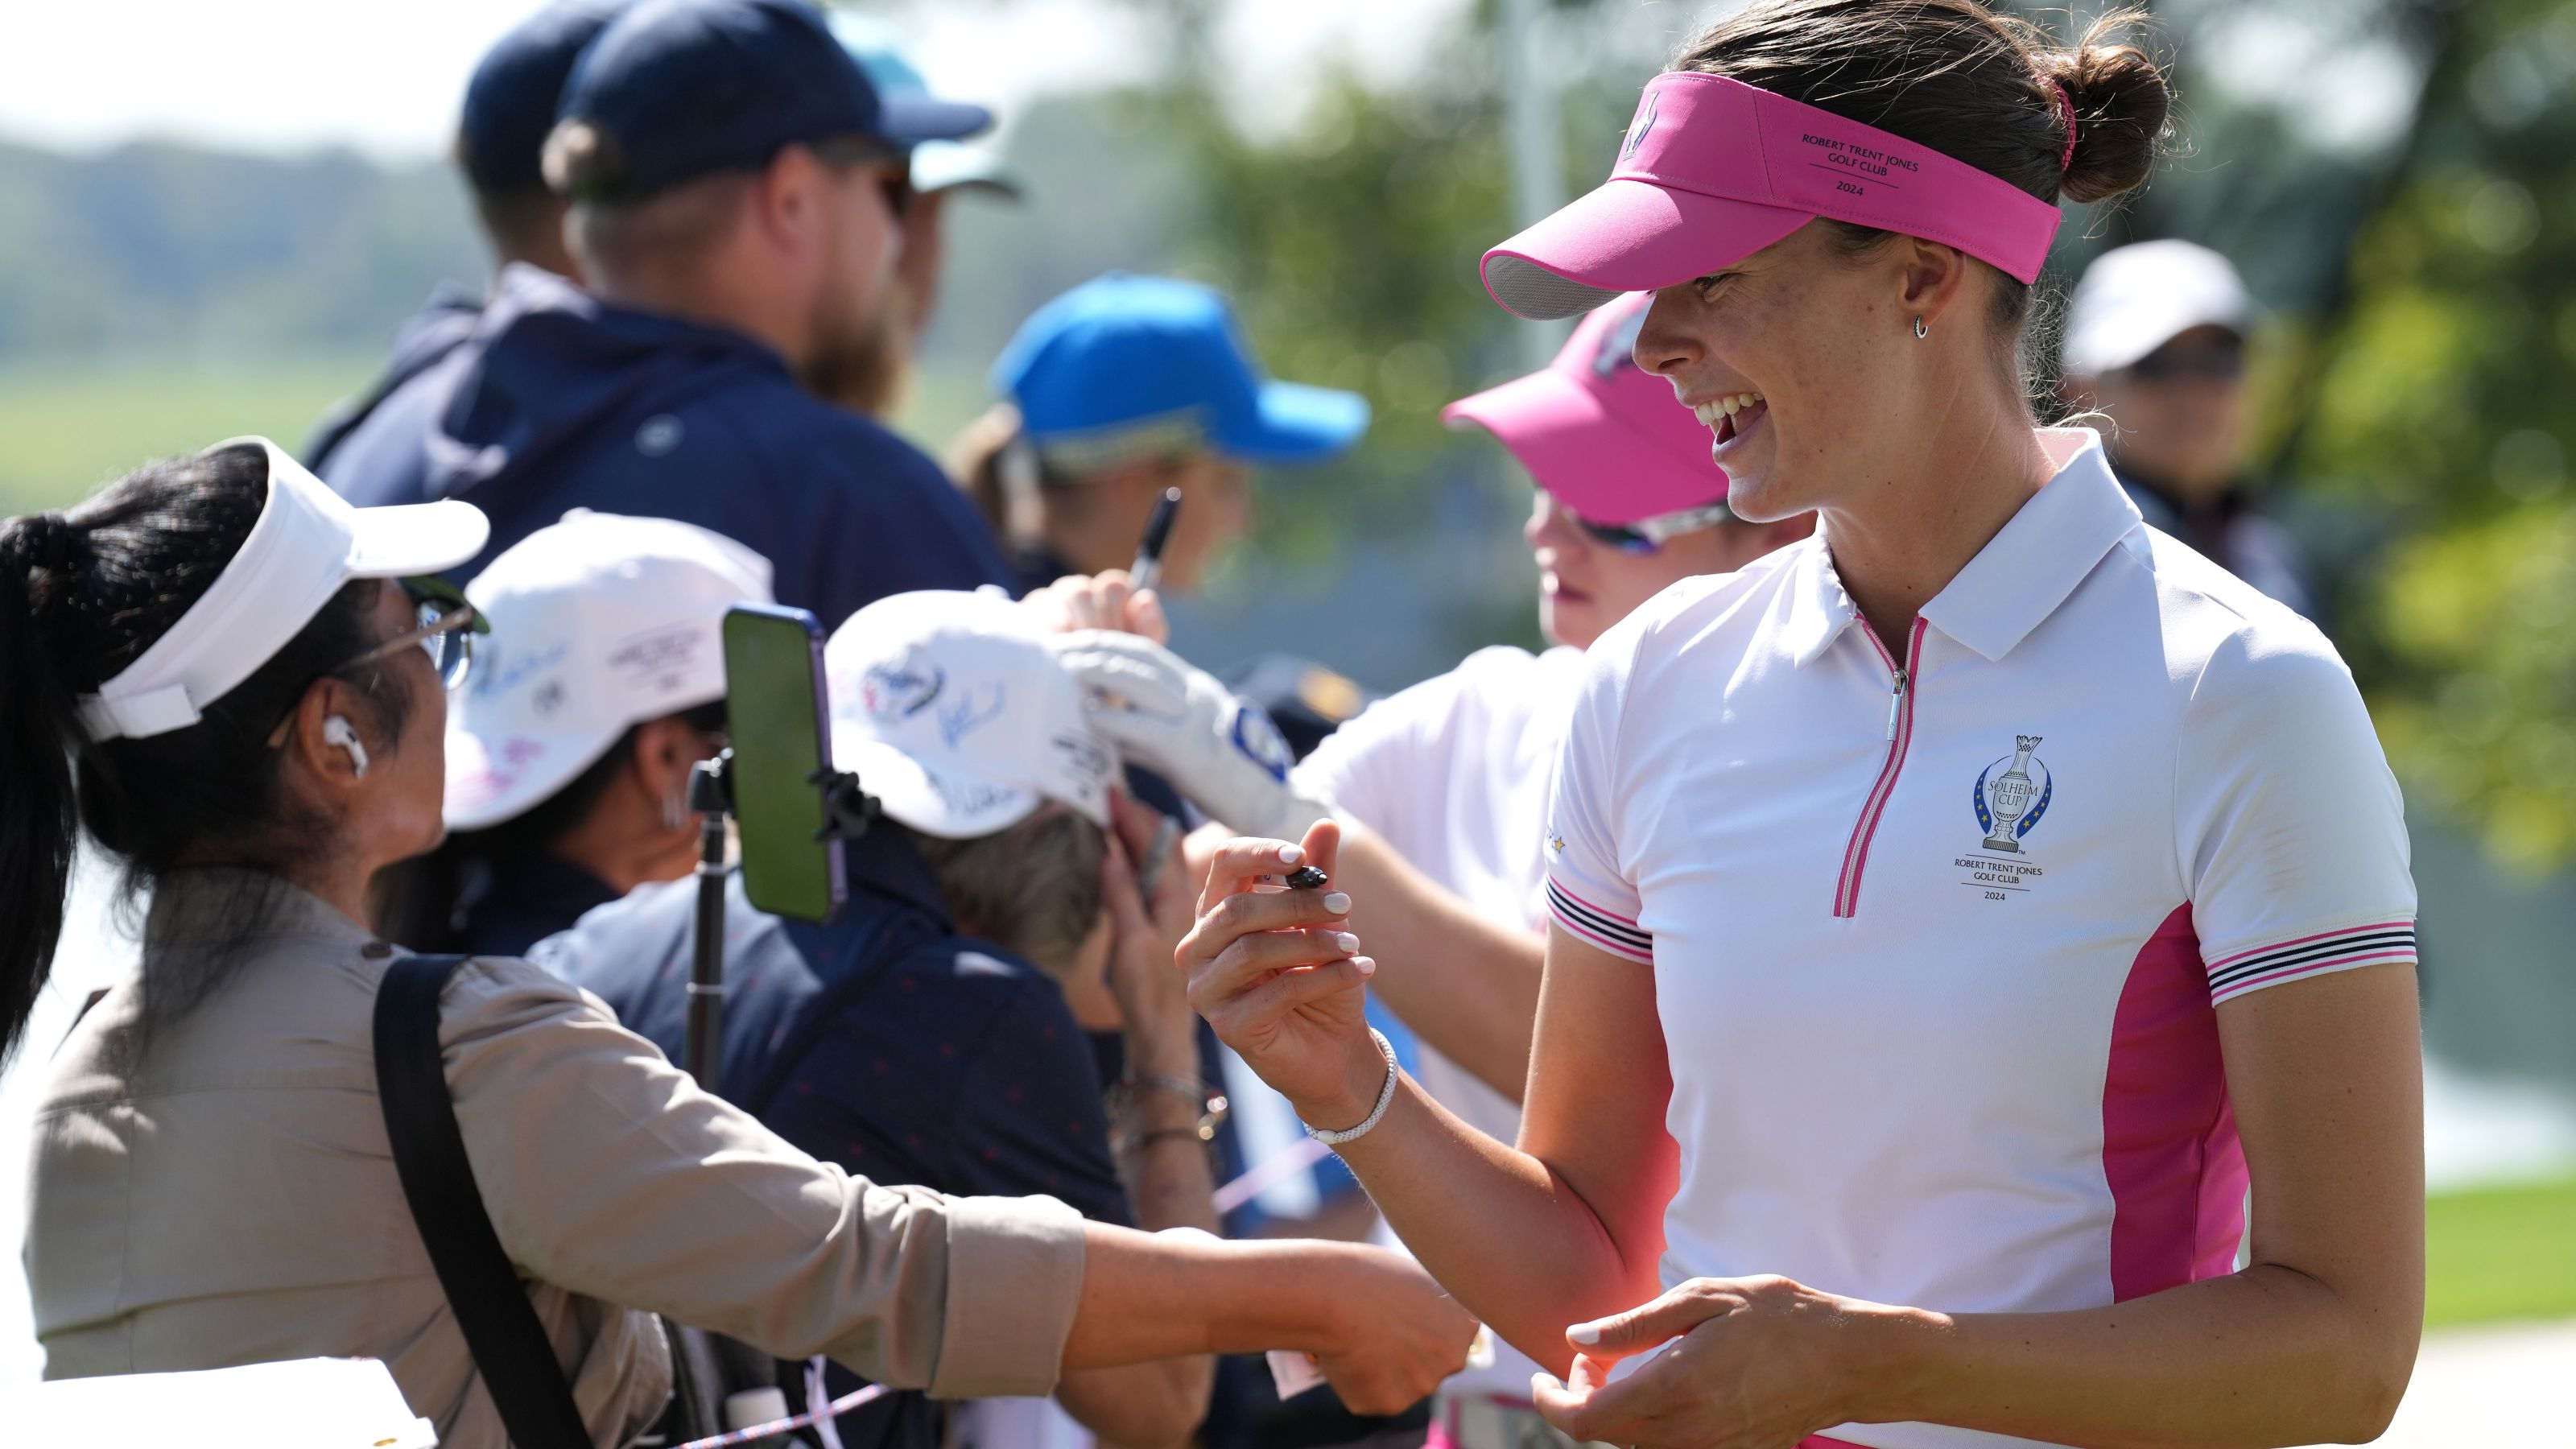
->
0, 438, 1471, 1447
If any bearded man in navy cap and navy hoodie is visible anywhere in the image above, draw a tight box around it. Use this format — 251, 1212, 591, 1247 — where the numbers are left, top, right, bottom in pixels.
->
324, 0, 1013, 626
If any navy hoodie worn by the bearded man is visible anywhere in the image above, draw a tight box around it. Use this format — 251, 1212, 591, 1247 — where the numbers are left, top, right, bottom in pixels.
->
317, 266, 1015, 629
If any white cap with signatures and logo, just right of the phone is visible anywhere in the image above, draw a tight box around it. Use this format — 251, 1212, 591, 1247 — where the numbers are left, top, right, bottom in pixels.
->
824, 590, 1118, 840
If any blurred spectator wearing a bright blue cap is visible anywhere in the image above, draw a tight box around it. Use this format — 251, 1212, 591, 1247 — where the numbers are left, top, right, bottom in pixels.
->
958, 270, 1368, 593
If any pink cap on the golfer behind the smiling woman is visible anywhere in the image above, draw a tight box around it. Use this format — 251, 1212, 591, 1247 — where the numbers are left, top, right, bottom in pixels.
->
1440, 291, 1726, 523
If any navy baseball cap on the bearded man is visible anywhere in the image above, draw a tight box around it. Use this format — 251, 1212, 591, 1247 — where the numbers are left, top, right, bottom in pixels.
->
556, 0, 992, 201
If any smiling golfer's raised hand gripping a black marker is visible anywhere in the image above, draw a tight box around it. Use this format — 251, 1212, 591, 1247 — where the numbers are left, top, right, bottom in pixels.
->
1174, 820, 1386, 1129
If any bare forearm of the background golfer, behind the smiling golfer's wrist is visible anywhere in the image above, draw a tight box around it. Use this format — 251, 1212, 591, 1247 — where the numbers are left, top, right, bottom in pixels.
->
1337, 825, 1546, 1101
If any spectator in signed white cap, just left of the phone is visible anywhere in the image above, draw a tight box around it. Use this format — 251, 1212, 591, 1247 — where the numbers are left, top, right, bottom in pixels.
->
376, 510, 770, 956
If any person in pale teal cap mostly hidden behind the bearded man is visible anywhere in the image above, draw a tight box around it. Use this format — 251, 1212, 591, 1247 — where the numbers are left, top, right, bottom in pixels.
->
814, 10, 1020, 420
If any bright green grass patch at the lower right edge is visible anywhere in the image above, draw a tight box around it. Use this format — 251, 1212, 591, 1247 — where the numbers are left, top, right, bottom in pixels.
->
2424, 1179, 2576, 1327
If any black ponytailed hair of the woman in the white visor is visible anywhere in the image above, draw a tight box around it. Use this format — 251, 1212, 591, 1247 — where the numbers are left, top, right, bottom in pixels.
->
0, 446, 410, 1059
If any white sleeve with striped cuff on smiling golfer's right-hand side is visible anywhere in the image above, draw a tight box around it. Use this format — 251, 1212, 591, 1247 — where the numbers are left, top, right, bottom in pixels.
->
2174, 621, 2417, 1003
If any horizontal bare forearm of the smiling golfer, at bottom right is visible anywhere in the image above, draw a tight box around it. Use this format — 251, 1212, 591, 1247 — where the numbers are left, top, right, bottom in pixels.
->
1860, 1263, 2417, 1449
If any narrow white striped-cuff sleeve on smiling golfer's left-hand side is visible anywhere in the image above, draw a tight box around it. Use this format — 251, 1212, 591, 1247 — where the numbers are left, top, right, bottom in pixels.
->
1546, 629, 1653, 964
